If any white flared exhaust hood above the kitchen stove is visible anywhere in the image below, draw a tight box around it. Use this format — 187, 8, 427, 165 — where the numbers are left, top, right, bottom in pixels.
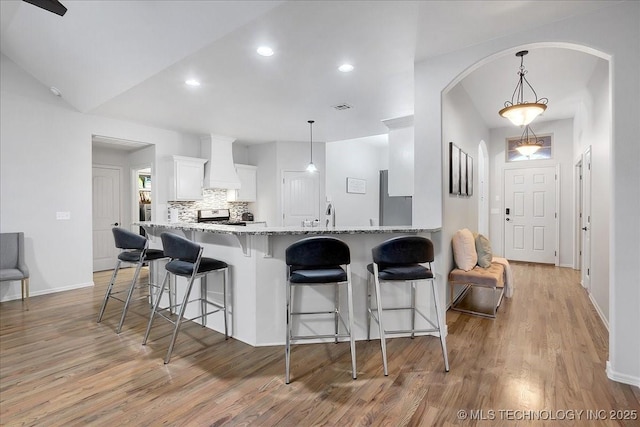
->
200, 134, 240, 189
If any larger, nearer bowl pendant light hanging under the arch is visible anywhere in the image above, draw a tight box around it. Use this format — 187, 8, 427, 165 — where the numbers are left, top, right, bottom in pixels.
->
498, 50, 549, 126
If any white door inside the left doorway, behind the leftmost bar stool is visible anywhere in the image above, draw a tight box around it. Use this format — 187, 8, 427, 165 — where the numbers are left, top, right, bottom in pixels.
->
92, 166, 122, 271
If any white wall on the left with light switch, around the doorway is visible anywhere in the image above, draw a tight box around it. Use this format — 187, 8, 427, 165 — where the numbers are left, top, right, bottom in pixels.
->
0, 55, 200, 300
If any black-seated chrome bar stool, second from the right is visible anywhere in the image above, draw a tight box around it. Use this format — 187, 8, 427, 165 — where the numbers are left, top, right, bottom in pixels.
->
285, 236, 356, 384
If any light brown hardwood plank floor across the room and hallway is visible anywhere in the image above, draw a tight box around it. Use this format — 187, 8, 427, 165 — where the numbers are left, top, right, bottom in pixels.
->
0, 263, 640, 426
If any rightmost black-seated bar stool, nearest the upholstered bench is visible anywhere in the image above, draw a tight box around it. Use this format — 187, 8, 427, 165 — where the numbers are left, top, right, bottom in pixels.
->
367, 236, 449, 375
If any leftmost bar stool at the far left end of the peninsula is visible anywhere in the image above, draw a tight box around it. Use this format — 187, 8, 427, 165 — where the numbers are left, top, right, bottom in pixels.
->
97, 227, 166, 334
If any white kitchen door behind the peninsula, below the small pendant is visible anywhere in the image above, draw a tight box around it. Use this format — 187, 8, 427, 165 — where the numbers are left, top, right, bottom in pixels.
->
282, 171, 320, 226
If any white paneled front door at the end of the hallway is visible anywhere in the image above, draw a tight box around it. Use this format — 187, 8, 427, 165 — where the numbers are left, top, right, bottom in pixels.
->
504, 167, 557, 264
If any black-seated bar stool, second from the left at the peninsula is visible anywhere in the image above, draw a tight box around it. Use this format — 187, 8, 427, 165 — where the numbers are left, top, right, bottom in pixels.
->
142, 233, 229, 364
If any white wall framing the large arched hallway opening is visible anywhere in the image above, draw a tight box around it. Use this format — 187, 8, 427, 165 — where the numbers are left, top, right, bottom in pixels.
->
413, 1, 640, 386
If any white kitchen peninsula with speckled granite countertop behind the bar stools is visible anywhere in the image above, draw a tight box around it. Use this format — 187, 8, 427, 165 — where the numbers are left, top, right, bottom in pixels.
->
134, 222, 445, 346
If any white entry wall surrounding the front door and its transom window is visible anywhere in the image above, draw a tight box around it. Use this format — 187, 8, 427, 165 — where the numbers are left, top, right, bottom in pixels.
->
487, 119, 574, 267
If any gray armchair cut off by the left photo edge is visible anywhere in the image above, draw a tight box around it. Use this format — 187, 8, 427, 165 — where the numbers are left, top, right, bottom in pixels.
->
0, 232, 29, 310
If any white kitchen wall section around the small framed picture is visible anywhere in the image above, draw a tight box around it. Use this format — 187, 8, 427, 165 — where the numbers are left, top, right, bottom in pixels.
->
326, 135, 388, 226
